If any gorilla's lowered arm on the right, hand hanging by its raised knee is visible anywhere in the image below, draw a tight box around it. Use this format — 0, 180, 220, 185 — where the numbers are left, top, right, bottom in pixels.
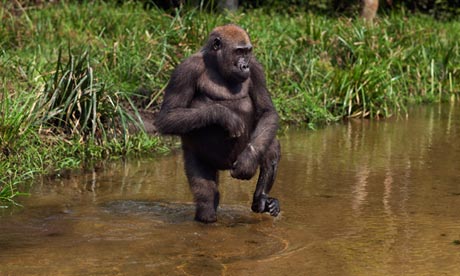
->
231, 62, 279, 179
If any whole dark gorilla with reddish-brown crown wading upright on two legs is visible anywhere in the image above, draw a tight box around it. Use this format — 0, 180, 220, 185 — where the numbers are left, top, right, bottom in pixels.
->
156, 24, 280, 223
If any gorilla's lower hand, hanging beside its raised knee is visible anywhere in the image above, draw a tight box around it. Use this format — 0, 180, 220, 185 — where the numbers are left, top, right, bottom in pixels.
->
231, 144, 259, 180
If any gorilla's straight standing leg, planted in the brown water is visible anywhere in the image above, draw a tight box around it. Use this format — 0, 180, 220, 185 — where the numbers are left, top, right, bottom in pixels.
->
184, 150, 219, 223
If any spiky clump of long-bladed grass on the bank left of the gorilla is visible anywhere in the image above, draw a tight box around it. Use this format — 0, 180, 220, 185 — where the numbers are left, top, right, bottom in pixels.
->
36, 50, 142, 143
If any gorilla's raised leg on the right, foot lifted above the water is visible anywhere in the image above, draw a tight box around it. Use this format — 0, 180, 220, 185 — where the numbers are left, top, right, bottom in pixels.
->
251, 139, 281, 217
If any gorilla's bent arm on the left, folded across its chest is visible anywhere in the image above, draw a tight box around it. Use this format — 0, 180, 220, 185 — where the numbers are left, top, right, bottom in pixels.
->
156, 56, 244, 137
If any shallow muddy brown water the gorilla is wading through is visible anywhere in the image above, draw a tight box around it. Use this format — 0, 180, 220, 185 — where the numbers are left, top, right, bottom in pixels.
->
0, 105, 460, 275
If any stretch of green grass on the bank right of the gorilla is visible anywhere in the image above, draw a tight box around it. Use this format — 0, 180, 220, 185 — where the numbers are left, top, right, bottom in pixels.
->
245, 13, 460, 123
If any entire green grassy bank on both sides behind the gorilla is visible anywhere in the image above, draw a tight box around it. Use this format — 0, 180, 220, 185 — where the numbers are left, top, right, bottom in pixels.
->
0, 1, 460, 206
